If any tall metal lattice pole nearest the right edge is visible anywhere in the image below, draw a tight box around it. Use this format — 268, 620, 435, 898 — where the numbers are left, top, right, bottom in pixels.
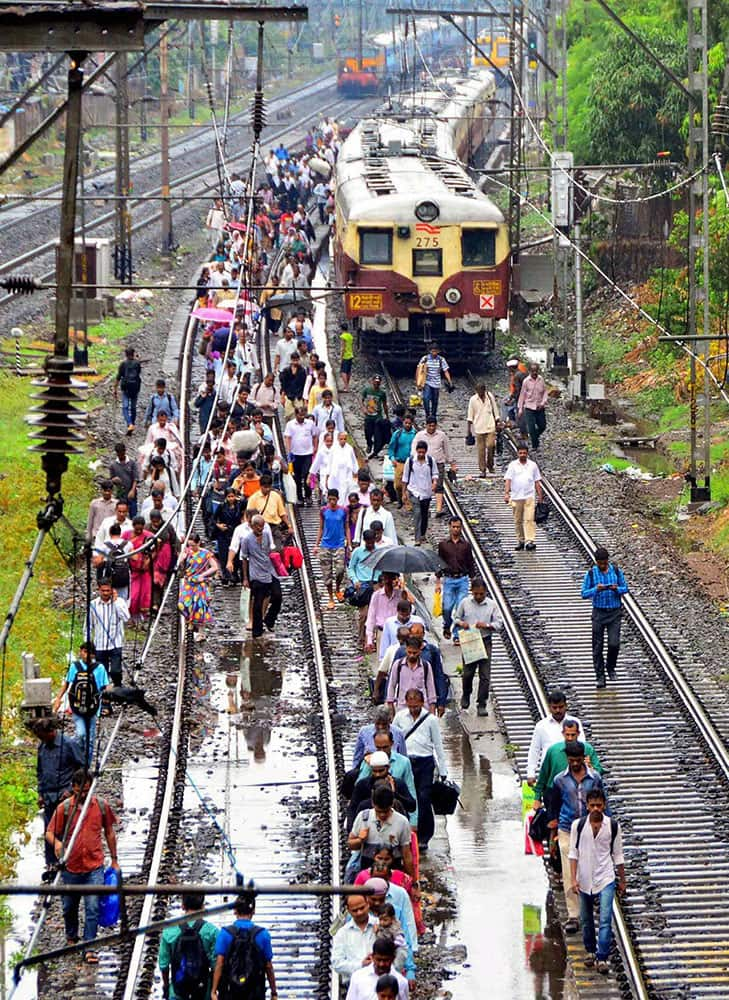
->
688, 0, 711, 502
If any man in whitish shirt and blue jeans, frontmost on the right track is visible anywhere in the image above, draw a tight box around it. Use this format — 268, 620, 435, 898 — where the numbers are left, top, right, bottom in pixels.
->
569, 788, 625, 975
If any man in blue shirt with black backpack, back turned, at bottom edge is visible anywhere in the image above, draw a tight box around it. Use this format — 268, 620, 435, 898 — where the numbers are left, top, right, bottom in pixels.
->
210, 892, 278, 1000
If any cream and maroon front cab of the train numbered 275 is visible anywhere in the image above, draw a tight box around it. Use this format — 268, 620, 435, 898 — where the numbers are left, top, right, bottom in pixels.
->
338, 222, 509, 362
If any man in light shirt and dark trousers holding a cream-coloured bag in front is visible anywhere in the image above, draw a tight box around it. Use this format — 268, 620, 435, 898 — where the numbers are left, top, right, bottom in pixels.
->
453, 576, 504, 716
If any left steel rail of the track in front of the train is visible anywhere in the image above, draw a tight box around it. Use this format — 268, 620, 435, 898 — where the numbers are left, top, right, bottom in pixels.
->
382, 363, 651, 1000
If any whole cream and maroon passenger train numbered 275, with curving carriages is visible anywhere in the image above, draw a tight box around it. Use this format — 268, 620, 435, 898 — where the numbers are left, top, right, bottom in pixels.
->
334, 70, 510, 360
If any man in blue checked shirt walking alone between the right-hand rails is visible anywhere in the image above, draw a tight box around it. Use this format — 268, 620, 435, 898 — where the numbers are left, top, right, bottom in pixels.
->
582, 546, 628, 688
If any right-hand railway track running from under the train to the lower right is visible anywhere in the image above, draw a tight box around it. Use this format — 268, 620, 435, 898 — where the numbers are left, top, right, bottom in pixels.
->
384, 364, 729, 1000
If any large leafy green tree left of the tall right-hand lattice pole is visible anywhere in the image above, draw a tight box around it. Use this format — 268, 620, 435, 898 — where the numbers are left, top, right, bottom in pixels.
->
582, 23, 687, 163
